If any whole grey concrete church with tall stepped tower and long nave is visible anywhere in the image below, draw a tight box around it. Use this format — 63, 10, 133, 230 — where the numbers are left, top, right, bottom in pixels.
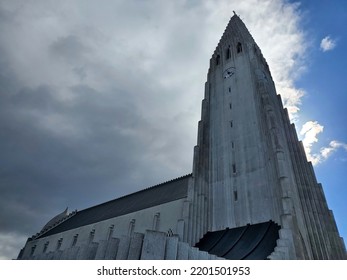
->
18, 14, 346, 260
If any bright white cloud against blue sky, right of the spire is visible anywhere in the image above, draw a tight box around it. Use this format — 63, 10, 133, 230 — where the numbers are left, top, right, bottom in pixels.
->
241, 1, 309, 122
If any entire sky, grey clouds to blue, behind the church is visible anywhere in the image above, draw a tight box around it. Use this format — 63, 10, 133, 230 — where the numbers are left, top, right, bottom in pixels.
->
0, 0, 347, 259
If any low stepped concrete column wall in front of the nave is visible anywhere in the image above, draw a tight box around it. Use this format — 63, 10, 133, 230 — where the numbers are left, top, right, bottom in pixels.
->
21, 230, 224, 260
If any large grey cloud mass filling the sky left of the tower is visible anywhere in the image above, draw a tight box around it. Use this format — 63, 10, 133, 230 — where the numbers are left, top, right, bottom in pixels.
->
0, 1, 227, 258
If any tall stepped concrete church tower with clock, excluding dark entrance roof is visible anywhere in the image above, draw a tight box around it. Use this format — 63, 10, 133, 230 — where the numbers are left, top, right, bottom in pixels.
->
185, 14, 345, 259
